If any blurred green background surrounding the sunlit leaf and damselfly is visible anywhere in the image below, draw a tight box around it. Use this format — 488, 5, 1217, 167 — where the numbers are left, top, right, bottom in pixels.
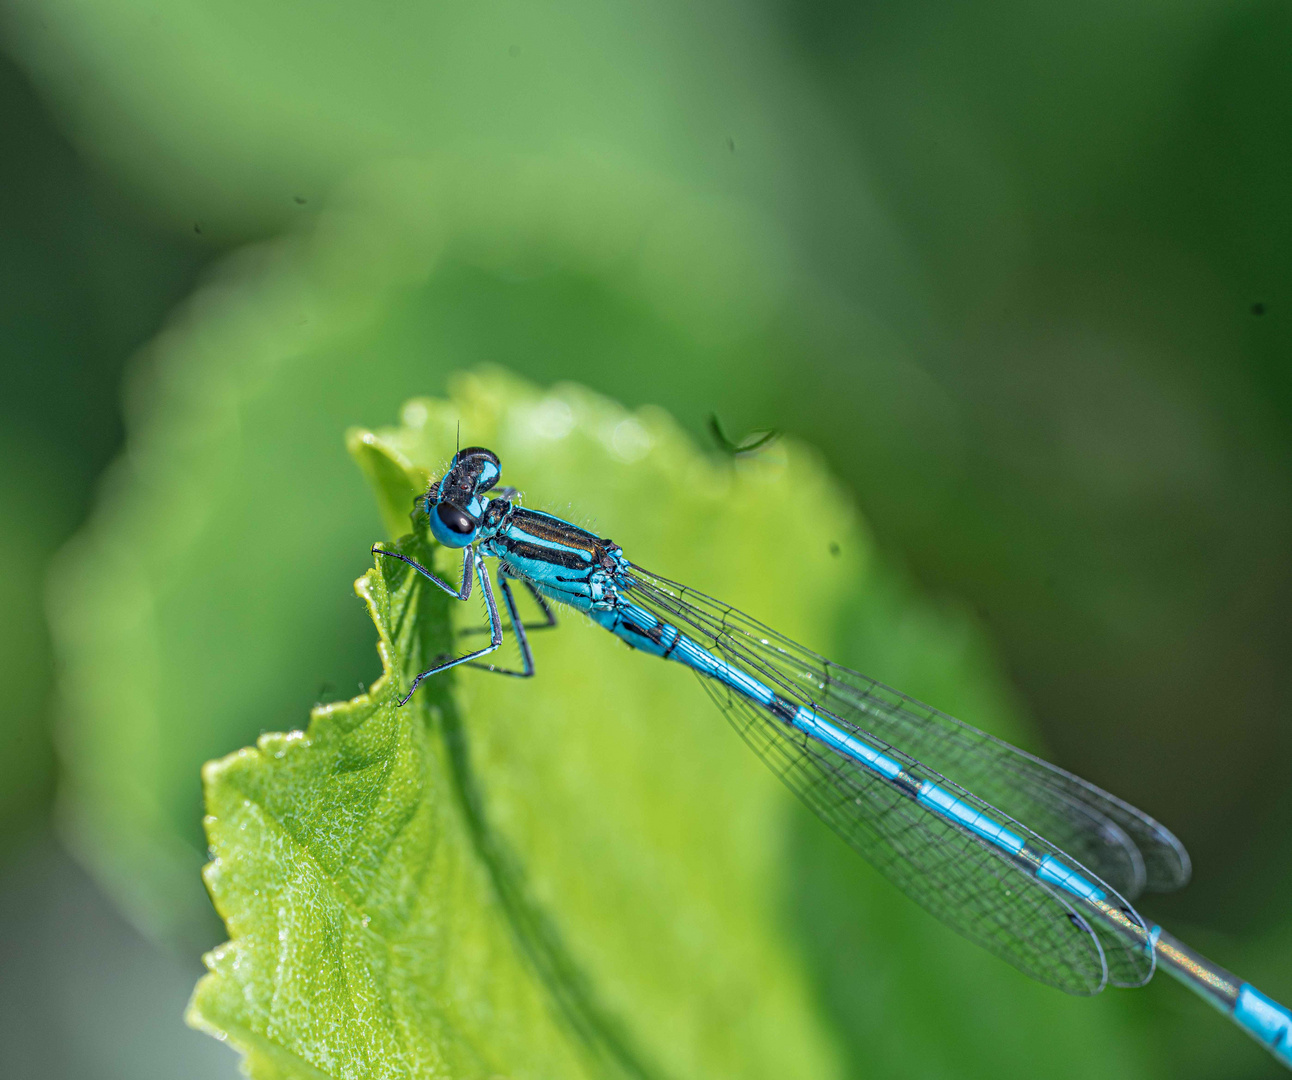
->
0, 0, 1292, 1077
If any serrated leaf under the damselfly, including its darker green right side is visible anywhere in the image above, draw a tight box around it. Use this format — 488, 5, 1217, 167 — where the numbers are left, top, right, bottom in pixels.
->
190, 371, 1152, 1077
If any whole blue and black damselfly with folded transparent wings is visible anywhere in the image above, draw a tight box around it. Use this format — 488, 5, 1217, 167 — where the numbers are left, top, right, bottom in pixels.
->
373, 447, 1292, 1066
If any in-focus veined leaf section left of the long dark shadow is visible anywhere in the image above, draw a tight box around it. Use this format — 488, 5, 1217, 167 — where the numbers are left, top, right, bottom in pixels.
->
190, 527, 594, 1077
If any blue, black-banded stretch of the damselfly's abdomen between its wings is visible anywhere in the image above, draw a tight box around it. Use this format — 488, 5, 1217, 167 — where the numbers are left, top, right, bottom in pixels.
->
592, 603, 1106, 904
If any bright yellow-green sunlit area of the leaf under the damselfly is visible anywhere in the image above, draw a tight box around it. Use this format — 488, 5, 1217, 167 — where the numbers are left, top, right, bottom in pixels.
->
190, 375, 858, 1077
